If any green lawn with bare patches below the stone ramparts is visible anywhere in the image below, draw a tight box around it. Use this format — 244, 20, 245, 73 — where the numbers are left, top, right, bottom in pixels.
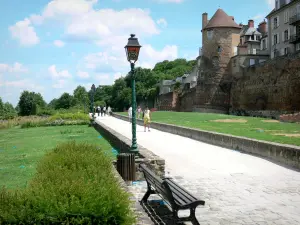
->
122, 112, 300, 146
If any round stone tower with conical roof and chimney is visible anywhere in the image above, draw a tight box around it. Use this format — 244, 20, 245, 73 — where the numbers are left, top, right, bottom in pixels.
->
194, 9, 241, 113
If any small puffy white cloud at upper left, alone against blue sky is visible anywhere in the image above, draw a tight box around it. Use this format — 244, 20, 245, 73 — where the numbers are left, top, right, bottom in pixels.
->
9, 18, 40, 46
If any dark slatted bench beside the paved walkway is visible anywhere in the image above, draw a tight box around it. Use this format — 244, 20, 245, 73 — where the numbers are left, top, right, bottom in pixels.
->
140, 164, 205, 225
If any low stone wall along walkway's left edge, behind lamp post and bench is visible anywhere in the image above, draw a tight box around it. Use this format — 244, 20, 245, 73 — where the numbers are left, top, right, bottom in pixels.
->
94, 122, 165, 180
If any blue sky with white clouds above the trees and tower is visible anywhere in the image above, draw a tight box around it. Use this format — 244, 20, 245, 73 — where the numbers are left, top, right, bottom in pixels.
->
0, 0, 275, 106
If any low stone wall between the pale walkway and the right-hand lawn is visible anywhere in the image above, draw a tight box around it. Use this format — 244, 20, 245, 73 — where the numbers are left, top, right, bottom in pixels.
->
113, 114, 300, 169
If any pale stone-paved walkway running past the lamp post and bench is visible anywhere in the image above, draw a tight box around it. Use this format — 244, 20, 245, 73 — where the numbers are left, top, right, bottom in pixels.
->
96, 117, 300, 225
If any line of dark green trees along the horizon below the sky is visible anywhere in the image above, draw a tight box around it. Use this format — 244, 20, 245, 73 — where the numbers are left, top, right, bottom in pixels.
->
0, 59, 196, 119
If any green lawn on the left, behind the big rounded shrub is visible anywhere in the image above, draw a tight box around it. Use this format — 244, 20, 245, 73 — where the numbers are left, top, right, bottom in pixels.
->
0, 125, 112, 189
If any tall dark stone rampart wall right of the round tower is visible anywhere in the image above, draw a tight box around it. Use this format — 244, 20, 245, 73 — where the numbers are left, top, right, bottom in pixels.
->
231, 55, 300, 116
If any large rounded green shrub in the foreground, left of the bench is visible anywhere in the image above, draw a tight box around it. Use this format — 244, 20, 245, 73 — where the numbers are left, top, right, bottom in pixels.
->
0, 142, 135, 225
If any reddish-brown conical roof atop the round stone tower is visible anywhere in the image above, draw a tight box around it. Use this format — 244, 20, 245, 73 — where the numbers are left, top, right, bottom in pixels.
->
204, 9, 241, 29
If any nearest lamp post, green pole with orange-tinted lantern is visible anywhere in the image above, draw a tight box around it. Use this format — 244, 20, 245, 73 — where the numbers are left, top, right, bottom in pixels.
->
125, 34, 142, 153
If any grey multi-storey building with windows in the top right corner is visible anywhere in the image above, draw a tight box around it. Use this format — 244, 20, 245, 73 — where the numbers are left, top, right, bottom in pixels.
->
267, 0, 300, 58
